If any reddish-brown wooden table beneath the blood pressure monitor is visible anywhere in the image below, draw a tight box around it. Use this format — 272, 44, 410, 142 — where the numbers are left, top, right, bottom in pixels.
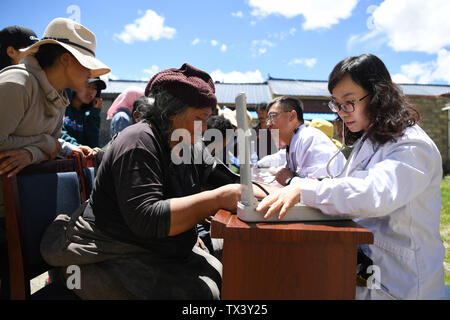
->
211, 210, 373, 300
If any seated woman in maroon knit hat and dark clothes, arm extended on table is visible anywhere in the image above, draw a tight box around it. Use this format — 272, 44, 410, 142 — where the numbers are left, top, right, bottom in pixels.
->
41, 64, 264, 299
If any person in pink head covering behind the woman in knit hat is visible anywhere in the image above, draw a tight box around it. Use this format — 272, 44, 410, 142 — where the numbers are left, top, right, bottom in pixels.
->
106, 87, 144, 137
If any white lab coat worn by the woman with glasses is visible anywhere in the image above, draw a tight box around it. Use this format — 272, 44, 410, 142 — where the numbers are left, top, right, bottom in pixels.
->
292, 125, 445, 299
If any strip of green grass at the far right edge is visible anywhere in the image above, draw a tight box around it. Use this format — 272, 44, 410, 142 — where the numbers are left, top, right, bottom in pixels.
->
441, 176, 450, 285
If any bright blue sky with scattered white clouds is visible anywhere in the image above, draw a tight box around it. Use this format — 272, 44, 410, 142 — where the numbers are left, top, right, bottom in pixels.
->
0, 0, 450, 84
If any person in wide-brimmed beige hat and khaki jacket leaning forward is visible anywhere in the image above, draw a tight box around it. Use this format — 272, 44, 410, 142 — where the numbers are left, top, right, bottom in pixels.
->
0, 18, 110, 176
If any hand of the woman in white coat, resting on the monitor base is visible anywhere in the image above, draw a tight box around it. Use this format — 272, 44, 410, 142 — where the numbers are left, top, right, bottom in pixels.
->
256, 185, 301, 220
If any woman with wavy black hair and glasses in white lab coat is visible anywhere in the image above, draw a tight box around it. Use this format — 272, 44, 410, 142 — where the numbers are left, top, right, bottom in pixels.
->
257, 54, 445, 299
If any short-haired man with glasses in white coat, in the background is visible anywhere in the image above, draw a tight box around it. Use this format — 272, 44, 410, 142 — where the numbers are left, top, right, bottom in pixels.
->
267, 97, 345, 186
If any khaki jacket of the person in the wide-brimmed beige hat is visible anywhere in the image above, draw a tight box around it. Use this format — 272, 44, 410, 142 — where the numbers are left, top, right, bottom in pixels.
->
0, 56, 69, 163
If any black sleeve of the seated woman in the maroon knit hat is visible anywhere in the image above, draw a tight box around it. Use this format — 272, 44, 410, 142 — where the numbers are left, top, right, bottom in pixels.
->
112, 148, 170, 238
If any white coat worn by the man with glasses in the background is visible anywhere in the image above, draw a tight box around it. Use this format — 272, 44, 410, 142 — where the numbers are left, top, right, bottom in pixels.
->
289, 124, 345, 178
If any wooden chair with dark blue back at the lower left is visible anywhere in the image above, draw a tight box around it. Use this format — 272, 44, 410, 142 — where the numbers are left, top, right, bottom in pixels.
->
1, 159, 82, 300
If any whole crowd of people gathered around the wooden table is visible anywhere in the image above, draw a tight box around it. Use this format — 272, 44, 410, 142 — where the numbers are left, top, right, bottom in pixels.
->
0, 18, 445, 299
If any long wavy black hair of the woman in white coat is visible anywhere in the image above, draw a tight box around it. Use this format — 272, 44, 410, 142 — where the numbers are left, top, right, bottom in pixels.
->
328, 54, 421, 144
